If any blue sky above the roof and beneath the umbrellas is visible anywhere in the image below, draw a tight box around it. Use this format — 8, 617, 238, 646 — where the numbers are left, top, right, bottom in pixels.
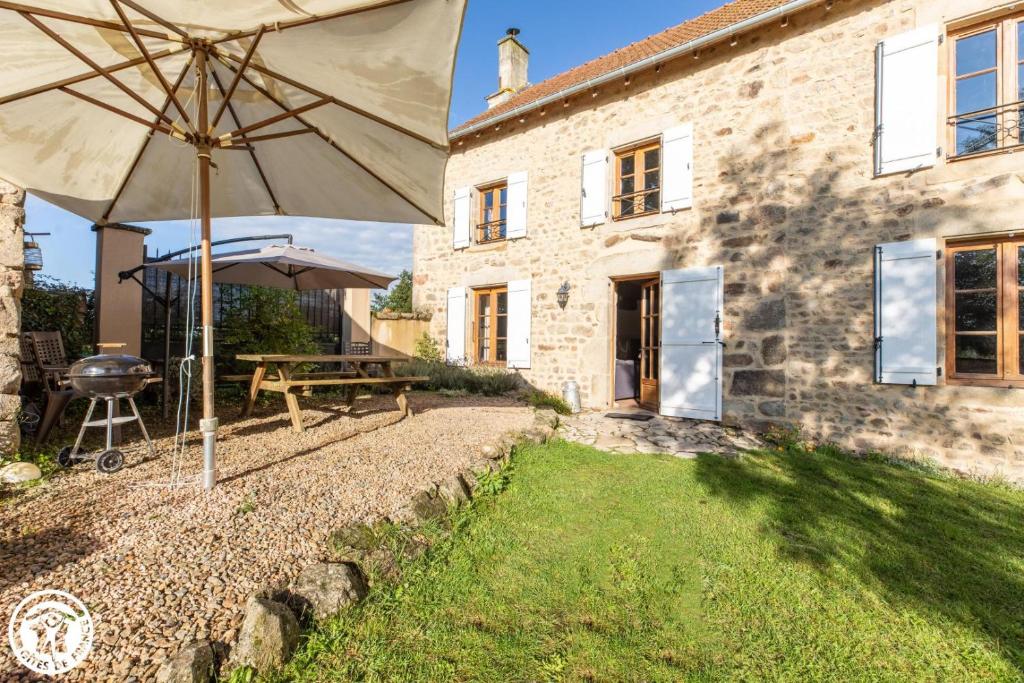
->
32, 0, 724, 287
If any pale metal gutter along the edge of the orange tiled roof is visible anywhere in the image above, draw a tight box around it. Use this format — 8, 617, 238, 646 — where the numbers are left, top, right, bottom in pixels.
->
449, 0, 826, 141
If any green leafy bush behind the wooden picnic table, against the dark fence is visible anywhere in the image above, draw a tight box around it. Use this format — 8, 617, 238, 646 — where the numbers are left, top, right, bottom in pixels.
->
216, 287, 318, 373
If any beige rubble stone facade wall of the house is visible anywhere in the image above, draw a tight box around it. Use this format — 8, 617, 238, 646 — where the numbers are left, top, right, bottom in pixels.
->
414, 0, 1024, 477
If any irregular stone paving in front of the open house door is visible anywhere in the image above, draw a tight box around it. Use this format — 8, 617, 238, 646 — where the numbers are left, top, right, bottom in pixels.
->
559, 411, 764, 458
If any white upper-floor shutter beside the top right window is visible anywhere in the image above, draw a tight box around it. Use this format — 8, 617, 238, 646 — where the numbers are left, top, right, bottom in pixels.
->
874, 25, 939, 175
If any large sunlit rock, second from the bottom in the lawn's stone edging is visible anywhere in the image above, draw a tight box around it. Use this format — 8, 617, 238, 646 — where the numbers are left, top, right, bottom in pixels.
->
231, 597, 299, 672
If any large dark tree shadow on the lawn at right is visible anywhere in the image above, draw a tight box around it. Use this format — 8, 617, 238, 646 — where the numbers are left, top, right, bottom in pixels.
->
696, 451, 1024, 670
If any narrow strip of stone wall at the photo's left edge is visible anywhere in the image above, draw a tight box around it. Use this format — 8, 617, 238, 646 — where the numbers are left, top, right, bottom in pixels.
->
0, 180, 25, 457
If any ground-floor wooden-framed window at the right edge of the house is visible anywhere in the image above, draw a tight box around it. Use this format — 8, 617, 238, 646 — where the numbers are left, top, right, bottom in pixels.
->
946, 238, 1024, 386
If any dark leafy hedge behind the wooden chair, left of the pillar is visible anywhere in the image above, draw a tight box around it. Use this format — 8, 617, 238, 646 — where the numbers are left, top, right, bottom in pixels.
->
22, 273, 96, 359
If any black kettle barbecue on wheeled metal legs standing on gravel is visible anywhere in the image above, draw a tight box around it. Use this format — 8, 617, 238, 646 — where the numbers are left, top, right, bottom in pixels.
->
57, 355, 156, 474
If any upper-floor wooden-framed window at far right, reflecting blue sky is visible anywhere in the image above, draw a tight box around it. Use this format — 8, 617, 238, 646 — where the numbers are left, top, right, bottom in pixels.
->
948, 13, 1024, 157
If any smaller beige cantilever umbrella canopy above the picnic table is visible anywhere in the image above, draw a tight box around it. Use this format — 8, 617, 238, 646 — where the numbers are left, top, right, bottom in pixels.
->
153, 245, 395, 290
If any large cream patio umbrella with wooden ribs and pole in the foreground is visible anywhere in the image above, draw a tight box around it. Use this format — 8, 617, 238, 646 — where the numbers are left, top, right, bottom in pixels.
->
0, 0, 465, 488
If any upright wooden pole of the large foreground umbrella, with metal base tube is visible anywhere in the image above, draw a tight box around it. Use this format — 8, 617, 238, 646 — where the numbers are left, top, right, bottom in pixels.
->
196, 45, 217, 490
